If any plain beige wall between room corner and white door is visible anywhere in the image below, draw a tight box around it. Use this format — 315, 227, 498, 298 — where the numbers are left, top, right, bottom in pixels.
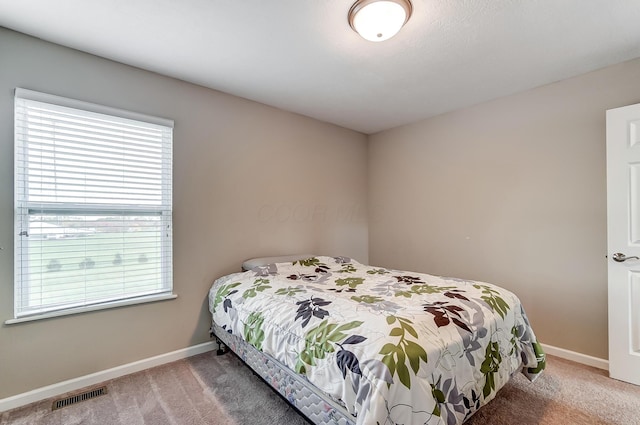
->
369, 56, 640, 358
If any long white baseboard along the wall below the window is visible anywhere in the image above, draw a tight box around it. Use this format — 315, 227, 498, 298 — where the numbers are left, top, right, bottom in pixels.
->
0, 342, 215, 412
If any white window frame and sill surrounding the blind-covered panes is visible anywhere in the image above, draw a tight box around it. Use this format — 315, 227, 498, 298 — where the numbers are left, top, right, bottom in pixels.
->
10, 88, 177, 324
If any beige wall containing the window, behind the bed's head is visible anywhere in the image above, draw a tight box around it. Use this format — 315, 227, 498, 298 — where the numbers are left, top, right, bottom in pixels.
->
0, 28, 368, 399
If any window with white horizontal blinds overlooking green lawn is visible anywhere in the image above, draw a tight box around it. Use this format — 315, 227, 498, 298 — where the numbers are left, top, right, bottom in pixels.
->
15, 89, 174, 319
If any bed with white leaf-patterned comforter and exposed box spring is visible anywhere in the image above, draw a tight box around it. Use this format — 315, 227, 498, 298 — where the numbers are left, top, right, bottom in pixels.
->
209, 256, 545, 425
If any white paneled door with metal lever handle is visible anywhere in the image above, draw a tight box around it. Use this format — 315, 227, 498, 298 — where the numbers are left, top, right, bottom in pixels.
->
607, 104, 640, 385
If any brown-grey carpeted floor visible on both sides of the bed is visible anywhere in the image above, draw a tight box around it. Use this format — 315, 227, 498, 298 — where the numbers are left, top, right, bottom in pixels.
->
0, 352, 640, 425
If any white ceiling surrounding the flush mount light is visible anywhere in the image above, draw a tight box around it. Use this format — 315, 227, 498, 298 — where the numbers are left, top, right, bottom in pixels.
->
0, 0, 640, 134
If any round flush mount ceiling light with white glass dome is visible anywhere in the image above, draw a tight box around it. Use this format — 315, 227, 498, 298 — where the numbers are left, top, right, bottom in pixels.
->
349, 0, 413, 41
